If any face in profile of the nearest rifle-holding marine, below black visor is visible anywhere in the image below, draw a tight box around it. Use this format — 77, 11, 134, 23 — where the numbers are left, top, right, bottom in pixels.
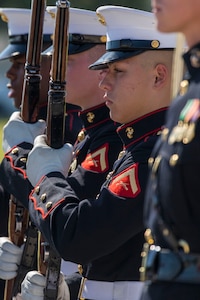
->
99, 54, 153, 123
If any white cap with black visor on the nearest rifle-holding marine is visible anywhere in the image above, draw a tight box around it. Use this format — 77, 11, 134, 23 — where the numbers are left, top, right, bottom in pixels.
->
90, 5, 176, 69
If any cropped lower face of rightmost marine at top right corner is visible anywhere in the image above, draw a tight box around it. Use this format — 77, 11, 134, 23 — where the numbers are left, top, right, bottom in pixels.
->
151, 0, 200, 44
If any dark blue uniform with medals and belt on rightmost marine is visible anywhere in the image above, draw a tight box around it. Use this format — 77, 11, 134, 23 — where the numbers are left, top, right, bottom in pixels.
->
139, 37, 200, 300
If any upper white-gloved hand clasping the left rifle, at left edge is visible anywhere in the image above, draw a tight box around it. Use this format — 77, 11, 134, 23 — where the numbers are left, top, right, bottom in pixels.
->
3, 111, 46, 153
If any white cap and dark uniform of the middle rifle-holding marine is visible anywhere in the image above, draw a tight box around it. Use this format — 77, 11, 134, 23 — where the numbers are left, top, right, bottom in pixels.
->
1, 8, 122, 299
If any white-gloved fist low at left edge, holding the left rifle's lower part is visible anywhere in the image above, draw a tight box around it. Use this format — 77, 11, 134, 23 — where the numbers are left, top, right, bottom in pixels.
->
0, 237, 23, 280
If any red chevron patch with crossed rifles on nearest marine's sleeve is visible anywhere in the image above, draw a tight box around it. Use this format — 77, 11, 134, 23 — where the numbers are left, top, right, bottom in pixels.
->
108, 164, 141, 198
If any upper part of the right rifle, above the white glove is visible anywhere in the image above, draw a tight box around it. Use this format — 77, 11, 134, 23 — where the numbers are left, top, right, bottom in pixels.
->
47, 1, 70, 148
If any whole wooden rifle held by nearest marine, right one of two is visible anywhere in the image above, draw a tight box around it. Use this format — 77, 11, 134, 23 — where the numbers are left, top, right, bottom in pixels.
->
40, 0, 70, 300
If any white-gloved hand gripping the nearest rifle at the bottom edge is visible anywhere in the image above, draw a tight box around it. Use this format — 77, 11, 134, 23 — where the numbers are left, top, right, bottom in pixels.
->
21, 271, 70, 300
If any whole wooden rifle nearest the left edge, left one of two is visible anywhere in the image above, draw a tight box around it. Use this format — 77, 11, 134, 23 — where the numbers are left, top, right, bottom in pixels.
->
4, 0, 46, 300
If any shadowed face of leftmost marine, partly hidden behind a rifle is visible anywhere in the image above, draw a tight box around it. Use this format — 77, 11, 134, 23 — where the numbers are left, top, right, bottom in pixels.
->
6, 54, 25, 108
